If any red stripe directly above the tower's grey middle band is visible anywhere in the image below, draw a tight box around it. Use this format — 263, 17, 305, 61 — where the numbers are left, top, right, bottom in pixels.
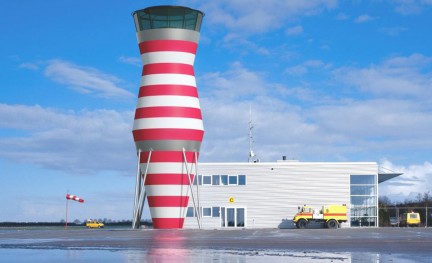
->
132, 129, 204, 142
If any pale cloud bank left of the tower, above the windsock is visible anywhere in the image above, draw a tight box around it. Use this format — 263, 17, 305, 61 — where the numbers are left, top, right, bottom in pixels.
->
0, 104, 135, 174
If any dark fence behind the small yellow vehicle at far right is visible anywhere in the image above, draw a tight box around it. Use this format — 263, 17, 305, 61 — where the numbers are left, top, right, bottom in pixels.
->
379, 206, 432, 227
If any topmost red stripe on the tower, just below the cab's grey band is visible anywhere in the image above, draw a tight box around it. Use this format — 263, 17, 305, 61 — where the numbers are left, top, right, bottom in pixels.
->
139, 40, 198, 54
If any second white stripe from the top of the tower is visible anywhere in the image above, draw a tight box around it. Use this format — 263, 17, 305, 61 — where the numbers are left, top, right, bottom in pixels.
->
140, 74, 196, 87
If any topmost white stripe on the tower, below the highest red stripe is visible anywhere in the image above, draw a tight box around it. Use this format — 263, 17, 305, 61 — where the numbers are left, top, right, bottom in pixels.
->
141, 51, 195, 65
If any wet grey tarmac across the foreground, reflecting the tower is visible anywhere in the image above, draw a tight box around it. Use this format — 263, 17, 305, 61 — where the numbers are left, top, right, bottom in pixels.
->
0, 228, 432, 262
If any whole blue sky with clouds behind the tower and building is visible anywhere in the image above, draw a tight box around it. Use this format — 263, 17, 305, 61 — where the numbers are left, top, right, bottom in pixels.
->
0, 0, 432, 222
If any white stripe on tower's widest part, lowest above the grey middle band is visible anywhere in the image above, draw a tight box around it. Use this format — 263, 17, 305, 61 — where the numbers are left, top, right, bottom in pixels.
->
133, 117, 204, 131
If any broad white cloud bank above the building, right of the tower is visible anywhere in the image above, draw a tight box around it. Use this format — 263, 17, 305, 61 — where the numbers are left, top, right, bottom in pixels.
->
199, 55, 432, 165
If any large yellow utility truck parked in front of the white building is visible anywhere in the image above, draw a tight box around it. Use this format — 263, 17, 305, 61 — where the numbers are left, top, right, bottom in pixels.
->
293, 205, 347, 229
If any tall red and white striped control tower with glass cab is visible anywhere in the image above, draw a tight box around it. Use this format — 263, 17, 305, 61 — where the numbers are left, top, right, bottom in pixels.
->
133, 6, 204, 228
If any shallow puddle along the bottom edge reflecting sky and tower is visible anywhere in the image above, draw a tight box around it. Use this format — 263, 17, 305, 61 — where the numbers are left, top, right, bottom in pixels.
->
0, 247, 430, 263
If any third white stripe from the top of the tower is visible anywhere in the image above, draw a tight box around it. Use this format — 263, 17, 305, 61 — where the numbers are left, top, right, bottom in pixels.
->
137, 95, 200, 109
